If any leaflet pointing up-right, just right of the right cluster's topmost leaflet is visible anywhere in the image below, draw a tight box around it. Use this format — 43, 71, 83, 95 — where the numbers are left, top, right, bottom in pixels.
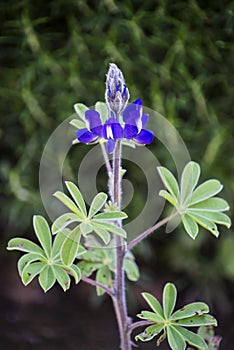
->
190, 180, 223, 205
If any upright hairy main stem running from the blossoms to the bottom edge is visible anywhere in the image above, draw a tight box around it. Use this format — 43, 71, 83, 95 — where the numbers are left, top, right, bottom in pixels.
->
112, 141, 132, 350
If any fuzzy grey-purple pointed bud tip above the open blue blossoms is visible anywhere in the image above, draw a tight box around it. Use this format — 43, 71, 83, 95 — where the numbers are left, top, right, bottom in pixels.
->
105, 63, 130, 118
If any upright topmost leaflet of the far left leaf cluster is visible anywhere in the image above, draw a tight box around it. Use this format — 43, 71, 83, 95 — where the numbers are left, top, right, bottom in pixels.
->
33, 215, 52, 258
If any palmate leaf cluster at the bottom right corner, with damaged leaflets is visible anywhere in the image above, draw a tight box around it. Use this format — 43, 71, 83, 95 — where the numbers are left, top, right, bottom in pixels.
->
136, 283, 217, 350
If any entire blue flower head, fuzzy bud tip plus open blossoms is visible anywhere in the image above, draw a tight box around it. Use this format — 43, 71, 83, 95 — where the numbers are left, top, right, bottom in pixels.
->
76, 63, 154, 153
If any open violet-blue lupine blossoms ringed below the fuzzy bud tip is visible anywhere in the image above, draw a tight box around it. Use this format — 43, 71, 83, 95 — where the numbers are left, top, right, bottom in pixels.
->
76, 99, 154, 153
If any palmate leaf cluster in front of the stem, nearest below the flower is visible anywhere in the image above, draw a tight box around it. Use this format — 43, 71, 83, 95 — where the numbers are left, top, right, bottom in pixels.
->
52, 181, 127, 252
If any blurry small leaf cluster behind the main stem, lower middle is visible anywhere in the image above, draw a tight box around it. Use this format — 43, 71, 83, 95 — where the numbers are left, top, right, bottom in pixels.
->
77, 248, 139, 295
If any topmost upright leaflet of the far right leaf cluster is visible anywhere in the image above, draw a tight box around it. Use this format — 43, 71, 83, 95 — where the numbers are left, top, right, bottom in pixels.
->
180, 162, 201, 204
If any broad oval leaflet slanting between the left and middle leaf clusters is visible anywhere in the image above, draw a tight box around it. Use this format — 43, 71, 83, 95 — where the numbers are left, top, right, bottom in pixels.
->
60, 226, 81, 266
